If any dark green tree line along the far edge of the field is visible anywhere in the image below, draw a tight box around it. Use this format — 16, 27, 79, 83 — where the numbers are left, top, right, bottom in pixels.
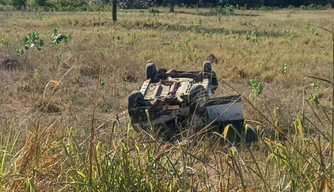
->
0, 0, 334, 12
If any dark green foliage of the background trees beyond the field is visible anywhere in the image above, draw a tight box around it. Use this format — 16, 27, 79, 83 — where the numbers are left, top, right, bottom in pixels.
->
0, 0, 334, 10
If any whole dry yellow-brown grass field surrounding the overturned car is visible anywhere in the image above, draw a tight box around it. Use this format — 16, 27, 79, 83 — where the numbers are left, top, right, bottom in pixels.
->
0, 9, 334, 191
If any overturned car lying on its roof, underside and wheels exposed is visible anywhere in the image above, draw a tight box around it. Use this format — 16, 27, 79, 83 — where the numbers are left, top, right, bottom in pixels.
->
128, 61, 253, 141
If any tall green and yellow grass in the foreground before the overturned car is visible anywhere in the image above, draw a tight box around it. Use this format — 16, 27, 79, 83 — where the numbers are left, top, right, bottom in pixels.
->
0, 103, 333, 191
